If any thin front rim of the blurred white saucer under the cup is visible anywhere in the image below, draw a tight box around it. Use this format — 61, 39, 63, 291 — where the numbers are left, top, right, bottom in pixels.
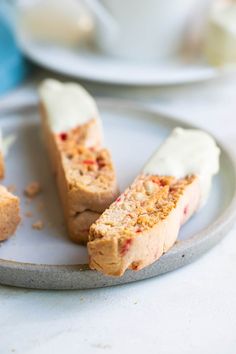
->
17, 30, 224, 87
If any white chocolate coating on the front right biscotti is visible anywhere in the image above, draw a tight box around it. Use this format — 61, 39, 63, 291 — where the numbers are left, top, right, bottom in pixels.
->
143, 128, 220, 207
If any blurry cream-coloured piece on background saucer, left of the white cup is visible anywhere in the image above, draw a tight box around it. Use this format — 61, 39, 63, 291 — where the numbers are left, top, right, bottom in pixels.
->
18, 0, 93, 45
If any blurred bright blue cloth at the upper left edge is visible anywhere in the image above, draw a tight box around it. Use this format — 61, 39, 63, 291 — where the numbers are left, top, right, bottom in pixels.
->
0, 14, 30, 95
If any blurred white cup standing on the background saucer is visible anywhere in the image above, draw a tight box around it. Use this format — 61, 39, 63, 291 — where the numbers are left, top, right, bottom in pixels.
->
85, 0, 209, 61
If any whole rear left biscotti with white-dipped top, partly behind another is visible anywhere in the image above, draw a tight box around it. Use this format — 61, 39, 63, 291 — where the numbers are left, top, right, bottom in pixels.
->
39, 80, 118, 243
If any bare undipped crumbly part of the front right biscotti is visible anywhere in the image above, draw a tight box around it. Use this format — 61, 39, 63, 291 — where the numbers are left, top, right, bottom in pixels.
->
88, 175, 200, 276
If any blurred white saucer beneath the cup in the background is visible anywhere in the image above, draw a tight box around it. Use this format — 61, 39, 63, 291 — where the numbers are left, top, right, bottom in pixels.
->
18, 31, 222, 86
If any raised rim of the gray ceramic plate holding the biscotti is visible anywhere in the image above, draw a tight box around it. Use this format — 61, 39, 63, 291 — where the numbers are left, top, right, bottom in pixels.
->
0, 98, 236, 289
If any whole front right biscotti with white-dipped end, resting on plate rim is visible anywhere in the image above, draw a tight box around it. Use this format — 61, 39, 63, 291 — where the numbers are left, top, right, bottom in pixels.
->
88, 128, 219, 276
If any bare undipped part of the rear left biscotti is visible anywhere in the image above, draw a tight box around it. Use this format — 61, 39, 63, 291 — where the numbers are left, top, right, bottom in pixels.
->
53, 128, 118, 243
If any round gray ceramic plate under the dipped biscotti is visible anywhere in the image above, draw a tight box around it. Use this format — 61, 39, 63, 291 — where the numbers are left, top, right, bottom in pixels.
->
0, 100, 236, 289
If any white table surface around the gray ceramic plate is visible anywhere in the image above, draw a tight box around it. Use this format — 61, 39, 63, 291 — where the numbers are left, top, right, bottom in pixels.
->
0, 73, 236, 354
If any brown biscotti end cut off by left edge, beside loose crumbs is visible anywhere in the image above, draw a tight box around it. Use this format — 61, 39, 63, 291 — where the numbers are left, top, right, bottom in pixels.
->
0, 186, 20, 241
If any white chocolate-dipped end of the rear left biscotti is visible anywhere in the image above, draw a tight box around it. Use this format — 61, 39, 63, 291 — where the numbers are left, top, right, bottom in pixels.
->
39, 79, 103, 147
